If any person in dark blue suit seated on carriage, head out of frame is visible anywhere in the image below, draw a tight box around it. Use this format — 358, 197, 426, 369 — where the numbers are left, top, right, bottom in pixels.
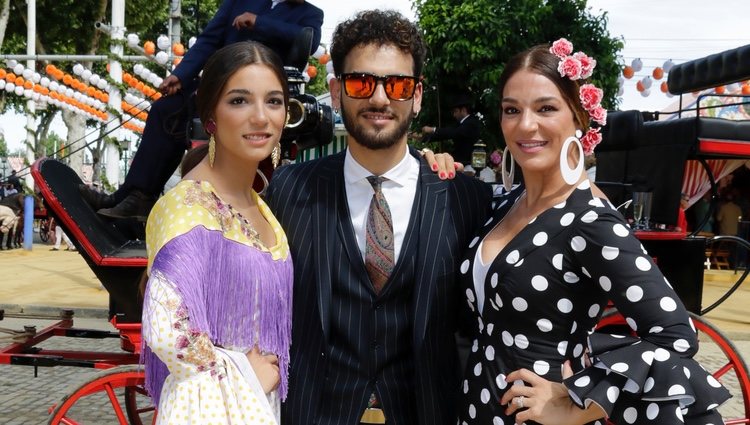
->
79, 0, 323, 220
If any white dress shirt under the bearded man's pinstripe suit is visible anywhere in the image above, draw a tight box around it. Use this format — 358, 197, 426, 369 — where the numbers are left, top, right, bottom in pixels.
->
344, 147, 419, 263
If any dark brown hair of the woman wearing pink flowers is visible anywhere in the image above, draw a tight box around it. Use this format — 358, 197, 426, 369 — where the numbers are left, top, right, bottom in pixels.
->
498, 44, 589, 133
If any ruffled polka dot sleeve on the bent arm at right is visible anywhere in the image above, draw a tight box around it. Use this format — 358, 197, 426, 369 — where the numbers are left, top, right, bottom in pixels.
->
565, 205, 730, 425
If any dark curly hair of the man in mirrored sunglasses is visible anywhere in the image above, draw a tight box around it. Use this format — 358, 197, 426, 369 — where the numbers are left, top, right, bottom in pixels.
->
331, 10, 426, 77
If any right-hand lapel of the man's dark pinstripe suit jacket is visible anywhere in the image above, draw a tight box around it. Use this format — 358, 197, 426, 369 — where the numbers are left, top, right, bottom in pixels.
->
412, 151, 450, 350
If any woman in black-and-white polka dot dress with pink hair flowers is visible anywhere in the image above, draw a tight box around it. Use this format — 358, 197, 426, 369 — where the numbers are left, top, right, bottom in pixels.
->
458, 39, 729, 425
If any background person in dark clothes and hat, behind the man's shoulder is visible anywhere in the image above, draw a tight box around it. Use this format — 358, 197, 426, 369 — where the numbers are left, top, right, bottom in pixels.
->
422, 94, 482, 165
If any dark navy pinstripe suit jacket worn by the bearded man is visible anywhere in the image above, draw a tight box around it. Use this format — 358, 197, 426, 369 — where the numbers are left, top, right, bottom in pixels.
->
268, 151, 491, 425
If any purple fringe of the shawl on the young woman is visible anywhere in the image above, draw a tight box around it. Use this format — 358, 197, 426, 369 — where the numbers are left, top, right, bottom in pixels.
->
141, 226, 293, 405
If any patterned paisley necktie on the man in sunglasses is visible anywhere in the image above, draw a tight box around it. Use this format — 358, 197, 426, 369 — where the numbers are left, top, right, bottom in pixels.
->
365, 176, 394, 294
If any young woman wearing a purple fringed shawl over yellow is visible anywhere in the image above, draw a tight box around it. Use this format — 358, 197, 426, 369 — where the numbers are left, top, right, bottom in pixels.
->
142, 42, 293, 425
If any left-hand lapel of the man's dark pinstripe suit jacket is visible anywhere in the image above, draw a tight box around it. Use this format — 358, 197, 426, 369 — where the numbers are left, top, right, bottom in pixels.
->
312, 154, 345, 342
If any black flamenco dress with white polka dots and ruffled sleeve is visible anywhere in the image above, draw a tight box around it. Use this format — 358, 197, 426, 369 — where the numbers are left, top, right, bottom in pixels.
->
458, 180, 729, 425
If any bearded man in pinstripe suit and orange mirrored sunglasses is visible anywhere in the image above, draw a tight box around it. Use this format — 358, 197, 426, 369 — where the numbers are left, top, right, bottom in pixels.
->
268, 11, 491, 425
